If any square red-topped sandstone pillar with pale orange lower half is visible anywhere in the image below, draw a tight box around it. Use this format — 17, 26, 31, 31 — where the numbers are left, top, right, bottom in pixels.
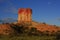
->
18, 8, 32, 23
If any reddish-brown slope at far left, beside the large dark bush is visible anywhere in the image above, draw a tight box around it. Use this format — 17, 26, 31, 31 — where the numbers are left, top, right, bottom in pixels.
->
0, 24, 14, 35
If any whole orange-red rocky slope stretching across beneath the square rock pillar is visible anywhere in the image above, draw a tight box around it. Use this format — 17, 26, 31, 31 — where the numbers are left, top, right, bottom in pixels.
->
0, 21, 60, 35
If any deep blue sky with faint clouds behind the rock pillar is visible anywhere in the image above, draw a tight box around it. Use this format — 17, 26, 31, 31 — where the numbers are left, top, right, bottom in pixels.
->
0, 0, 60, 26
